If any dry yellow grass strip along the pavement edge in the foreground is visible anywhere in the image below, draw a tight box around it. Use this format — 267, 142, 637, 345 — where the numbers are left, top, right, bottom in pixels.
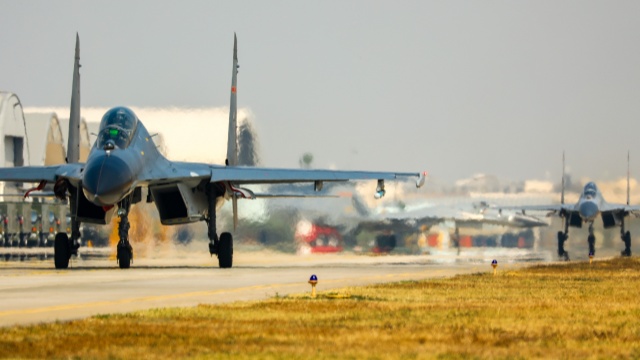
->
0, 259, 640, 359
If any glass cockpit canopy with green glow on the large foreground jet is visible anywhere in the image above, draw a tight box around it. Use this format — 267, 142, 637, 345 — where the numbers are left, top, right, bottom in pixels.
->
96, 107, 138, 150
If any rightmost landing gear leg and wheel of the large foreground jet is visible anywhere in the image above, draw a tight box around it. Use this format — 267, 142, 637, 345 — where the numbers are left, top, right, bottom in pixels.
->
205, 184, 233, 268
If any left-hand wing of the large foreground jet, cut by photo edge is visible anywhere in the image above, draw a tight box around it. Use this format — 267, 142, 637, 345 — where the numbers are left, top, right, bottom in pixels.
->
0, 163, 84, 183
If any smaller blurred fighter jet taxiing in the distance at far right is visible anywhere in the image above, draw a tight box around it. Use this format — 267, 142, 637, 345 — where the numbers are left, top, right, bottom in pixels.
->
503, 154, 640, 260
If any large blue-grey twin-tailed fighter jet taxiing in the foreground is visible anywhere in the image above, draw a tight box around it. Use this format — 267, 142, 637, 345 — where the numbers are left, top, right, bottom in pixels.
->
0, 34, 425, 269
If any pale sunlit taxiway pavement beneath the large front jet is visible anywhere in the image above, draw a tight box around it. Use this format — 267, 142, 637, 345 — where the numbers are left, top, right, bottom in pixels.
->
0, 250, 544, 326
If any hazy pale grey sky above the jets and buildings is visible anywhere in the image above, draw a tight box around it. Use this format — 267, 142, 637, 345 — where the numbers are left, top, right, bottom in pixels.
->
0, 0, 640, 180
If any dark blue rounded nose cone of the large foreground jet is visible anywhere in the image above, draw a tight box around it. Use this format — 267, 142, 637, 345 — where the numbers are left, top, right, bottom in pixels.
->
82, 154, 133, 206
